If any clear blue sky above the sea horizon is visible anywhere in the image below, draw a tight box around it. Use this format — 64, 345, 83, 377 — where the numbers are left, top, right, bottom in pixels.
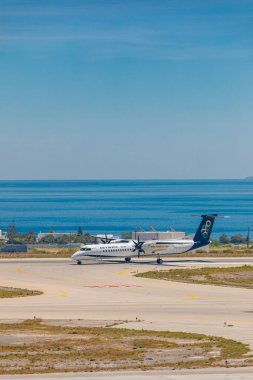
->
0, 0, 253, 179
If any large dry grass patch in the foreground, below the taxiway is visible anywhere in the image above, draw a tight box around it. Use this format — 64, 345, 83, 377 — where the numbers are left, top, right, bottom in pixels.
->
0, 319, 249, 374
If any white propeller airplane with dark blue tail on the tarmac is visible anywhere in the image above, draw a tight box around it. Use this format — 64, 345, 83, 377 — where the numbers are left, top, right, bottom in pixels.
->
71, 214, 218, 265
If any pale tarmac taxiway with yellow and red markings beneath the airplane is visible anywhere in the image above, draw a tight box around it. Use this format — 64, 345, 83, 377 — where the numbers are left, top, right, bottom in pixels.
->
0, 257, 253, 380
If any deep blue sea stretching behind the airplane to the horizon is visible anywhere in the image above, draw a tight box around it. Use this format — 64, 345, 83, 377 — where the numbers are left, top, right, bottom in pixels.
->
0, 180, 253, 236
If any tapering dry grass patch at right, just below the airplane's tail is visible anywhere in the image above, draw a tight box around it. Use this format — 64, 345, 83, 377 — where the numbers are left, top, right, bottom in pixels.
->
136, 265, 253, 289
